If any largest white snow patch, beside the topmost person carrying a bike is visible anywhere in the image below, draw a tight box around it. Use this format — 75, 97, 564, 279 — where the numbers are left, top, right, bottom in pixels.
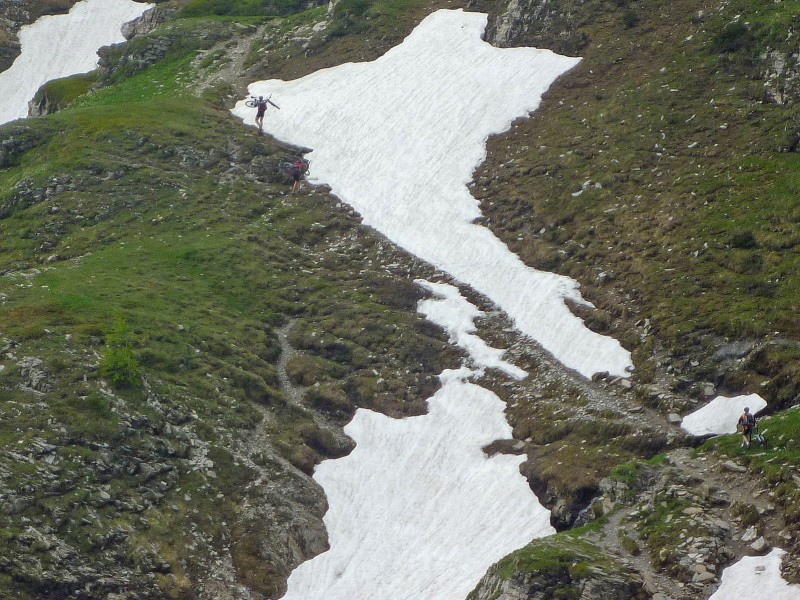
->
233, 10, 631, 376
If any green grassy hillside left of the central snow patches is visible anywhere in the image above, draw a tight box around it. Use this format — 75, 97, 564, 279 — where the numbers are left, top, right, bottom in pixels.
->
0, 4, 448, 598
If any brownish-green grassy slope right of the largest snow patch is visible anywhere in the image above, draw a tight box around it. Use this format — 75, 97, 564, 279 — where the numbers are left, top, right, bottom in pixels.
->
475, 0, 800, 408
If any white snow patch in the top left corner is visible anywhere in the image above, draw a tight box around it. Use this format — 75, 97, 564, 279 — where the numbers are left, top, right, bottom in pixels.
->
0, 0, 152, 125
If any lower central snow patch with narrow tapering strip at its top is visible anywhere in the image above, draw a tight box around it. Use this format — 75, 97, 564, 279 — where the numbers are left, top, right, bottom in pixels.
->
284, 281, 554, 600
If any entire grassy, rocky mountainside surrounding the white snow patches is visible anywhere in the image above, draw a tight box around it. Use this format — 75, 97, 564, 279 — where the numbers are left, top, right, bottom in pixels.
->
0, 0, 800, 599
